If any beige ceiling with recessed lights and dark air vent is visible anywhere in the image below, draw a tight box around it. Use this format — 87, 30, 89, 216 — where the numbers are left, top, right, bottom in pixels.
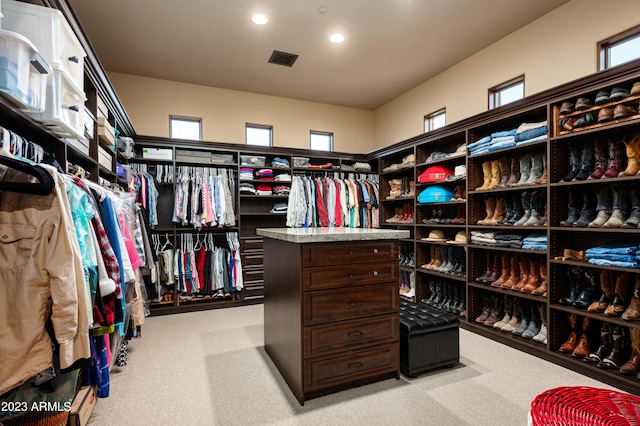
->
69, 0, 569, 109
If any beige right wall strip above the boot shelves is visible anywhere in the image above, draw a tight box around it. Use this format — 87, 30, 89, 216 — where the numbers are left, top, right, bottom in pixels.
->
372, 0, 640, 150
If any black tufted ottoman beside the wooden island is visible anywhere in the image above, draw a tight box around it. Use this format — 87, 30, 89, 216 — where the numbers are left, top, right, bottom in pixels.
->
400, 300, 460, 377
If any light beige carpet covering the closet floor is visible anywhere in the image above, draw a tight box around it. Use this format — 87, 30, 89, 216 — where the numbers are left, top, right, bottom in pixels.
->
89, 305, 615, 426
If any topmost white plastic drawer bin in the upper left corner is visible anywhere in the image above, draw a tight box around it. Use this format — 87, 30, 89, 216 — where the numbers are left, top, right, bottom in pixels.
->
1, 0, 87, 92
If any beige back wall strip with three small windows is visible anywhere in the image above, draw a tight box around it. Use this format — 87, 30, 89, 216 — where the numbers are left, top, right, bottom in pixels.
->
109, 73, 373, 153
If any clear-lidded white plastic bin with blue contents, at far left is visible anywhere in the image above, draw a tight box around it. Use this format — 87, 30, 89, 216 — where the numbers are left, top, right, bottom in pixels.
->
0, 30, 51, 111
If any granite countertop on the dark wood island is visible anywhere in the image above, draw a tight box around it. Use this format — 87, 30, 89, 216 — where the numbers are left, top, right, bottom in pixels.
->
256, 228, 410, 243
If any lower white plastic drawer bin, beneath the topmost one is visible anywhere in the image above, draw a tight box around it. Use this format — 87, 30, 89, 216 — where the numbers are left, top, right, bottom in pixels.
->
29, 68, 86, 139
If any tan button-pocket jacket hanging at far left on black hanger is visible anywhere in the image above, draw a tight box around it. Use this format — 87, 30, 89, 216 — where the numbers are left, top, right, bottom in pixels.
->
0, 149, 92, 394
